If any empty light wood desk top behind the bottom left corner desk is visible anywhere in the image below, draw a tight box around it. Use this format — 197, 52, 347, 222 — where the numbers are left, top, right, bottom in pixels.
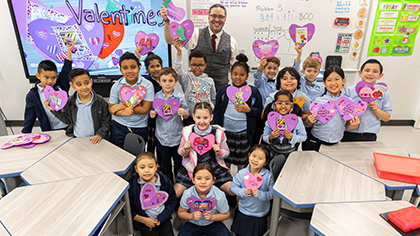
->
21, 138, 135, 184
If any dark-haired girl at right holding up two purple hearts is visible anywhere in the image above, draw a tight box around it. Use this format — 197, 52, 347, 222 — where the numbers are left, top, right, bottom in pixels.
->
306, 66, 360, 151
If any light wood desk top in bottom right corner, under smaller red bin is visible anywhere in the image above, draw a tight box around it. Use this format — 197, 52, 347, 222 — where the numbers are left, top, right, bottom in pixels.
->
310, 201, 412, 236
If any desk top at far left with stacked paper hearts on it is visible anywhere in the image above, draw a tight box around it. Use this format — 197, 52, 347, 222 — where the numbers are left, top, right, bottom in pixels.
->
0, 130, 70, 178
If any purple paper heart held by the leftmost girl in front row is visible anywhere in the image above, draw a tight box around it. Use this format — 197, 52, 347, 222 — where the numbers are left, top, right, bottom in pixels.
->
140, 183, 169, 210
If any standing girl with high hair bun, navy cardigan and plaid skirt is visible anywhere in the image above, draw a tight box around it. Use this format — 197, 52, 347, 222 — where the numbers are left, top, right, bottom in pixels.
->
214, 54, 262, 169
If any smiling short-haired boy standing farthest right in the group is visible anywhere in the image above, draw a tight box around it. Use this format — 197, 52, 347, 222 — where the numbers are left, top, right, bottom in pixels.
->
341, 59, 392, 142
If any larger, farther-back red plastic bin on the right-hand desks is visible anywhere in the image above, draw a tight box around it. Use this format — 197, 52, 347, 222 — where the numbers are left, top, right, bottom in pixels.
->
373, 152, 420, 184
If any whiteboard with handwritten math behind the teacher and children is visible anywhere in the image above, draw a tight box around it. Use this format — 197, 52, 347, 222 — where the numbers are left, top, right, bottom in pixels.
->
188, 0, 371, 71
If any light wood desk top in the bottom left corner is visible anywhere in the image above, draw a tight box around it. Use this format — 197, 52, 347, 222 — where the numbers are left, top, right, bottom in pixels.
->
0, 173, 128, 236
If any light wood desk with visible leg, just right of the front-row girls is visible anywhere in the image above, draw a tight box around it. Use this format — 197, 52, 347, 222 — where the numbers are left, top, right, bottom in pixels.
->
270, 151, 385, 236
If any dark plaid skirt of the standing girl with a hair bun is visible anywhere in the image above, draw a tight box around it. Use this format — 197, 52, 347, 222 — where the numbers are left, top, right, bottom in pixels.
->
225, 130, 249, 165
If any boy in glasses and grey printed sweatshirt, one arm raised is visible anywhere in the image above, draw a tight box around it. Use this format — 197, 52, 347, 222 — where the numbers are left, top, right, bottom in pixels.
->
174, 39, 216, 125
